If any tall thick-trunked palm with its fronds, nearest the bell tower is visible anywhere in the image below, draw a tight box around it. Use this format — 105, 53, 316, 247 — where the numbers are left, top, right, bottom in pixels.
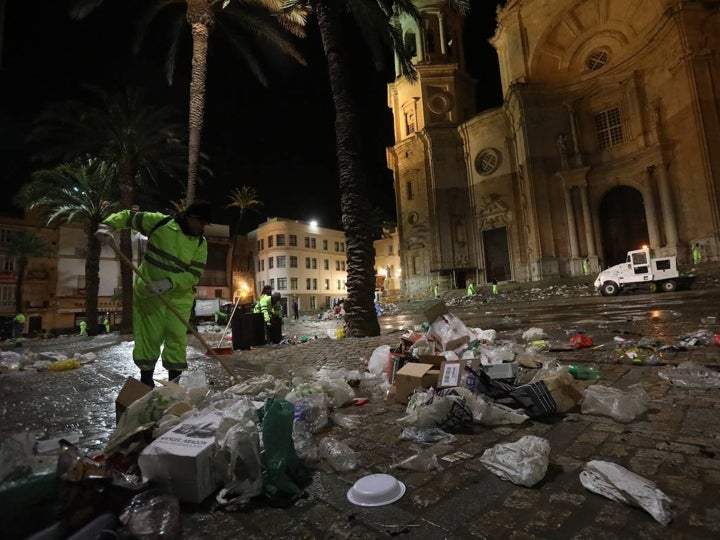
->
285, 0, 470, 337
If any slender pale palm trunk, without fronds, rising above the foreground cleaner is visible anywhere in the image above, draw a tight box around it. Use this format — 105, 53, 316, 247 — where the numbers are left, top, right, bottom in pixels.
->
185, 0, 214, 204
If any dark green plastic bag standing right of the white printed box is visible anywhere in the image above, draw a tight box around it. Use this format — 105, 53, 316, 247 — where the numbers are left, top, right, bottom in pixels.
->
258, 398, 311, 506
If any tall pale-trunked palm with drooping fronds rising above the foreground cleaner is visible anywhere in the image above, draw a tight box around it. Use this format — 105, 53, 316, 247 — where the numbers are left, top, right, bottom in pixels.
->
70, 0, 305, 204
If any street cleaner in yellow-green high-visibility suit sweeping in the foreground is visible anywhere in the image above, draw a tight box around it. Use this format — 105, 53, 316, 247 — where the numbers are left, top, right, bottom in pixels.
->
95, 201, 212, 387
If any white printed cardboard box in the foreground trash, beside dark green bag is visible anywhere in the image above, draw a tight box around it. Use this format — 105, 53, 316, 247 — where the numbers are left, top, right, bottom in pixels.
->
138, 407, 222, 503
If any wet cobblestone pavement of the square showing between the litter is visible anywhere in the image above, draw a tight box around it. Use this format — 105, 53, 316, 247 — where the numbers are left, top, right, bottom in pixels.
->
0, 272, 720, 540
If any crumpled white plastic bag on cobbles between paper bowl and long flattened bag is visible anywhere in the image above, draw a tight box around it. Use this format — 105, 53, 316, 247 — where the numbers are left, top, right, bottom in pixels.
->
480, 435, 550, 487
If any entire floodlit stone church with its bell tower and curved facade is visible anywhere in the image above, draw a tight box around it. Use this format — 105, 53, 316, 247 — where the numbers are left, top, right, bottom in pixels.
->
387, 0, 720, 294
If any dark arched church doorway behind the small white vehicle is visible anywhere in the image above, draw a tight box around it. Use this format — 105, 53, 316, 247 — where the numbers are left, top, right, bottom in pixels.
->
600, 186, 649, 267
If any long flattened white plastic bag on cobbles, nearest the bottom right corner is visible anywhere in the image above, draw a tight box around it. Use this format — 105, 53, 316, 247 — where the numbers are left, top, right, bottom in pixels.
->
580, 461, 672, 525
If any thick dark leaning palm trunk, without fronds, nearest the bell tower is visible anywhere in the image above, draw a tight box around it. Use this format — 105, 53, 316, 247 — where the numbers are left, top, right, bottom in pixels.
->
314, 2, 380, 337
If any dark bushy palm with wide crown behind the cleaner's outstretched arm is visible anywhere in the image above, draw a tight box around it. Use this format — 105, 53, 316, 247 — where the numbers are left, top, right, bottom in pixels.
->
28, 87, 187, 332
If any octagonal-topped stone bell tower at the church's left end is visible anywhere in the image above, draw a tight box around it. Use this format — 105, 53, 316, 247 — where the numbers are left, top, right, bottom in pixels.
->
387, 0, 477, 294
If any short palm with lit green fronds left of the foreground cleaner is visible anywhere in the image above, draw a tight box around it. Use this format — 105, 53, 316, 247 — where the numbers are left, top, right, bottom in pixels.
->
17, 160, 121, 335
